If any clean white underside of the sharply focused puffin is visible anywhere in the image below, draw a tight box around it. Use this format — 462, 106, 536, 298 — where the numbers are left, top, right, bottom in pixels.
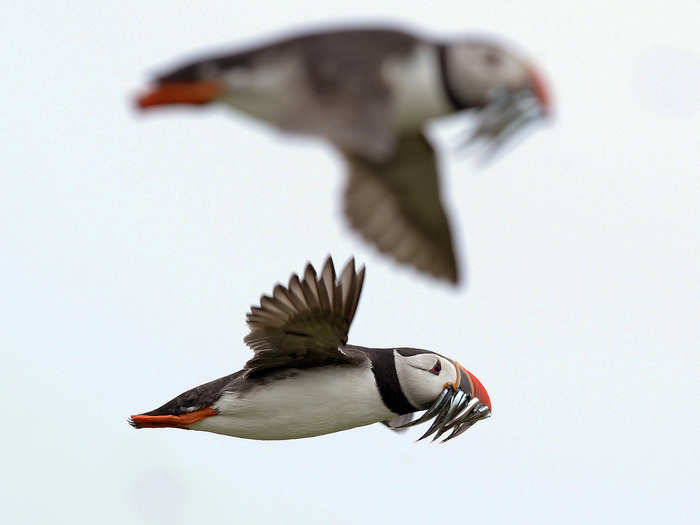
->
190, 366, 396, 439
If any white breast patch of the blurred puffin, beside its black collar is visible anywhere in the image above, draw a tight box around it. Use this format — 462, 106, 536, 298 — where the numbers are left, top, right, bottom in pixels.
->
382, 44, 452, 130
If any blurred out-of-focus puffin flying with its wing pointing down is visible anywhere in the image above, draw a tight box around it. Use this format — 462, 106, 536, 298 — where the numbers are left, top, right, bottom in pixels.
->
136, 27, 551, 284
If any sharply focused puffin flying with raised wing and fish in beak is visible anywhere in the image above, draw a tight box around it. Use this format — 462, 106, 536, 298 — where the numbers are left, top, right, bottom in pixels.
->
128, 256, 491, 441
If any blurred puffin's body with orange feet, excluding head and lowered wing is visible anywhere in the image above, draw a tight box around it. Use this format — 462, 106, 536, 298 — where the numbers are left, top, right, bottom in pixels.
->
139, 30, 456, 156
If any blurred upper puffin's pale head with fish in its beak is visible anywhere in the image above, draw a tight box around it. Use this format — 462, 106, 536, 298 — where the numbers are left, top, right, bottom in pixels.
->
443, 40, 551, 154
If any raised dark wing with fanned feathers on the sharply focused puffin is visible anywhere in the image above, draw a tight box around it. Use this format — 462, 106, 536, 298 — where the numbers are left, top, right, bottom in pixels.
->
244, 257, 365, 376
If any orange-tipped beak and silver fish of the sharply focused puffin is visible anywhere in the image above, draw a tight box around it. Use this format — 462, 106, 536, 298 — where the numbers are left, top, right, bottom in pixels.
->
395, 361, 491, 443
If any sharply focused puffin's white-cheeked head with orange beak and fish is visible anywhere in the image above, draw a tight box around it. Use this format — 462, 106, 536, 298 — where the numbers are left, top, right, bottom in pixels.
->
394, 348, 491, 441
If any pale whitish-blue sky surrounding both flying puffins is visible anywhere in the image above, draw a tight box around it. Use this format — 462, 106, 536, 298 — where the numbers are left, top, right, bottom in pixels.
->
0, 0, 700, 525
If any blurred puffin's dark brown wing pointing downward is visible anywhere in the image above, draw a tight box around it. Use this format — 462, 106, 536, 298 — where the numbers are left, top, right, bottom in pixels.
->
345, 134, 458, 283
